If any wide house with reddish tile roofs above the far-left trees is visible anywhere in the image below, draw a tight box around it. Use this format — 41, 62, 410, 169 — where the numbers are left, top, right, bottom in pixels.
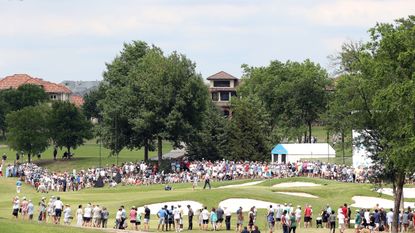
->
0, 74, 83, 106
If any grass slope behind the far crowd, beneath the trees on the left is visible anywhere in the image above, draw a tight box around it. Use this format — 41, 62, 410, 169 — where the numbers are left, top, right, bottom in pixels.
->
0, 140, 172, 171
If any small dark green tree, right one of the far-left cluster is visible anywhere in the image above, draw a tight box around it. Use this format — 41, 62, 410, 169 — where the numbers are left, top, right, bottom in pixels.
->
49, 101, 92, 153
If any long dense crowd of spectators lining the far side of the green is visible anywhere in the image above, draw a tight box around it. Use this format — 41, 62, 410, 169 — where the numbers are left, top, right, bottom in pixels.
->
1, 159, 373, 193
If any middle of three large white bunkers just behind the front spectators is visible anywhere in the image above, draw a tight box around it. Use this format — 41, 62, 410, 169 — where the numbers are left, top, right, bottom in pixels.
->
219, 198, 277, 213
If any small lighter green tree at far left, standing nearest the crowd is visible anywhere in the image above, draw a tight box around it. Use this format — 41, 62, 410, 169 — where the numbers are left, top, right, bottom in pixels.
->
6, 105, 49, 163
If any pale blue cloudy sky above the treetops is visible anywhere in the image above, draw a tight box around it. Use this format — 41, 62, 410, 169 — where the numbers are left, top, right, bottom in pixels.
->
0, 0, 415, 82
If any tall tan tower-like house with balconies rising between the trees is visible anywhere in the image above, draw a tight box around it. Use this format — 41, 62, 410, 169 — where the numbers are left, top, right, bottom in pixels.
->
207, 71, 239, 116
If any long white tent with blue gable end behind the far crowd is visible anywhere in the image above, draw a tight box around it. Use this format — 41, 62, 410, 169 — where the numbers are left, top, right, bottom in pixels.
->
271, 143, 336, 163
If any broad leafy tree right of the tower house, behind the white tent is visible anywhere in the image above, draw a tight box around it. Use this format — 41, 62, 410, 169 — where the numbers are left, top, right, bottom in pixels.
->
240, 60, 329, 142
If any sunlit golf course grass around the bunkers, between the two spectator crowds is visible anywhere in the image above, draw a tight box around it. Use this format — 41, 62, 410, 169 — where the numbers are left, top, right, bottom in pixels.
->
0, 175, 413, 233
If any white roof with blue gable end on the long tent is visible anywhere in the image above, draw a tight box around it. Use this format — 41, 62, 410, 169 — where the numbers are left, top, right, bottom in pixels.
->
271, 143, 336, 155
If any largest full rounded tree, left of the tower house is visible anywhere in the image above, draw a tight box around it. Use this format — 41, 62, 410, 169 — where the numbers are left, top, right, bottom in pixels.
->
100, 42, 208, 166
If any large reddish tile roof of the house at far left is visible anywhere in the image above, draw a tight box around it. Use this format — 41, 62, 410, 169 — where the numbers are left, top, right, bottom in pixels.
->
0, 74, 72, 94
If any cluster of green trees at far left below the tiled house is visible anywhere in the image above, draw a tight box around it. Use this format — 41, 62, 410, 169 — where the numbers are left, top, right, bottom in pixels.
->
0, 84, 93, 162
